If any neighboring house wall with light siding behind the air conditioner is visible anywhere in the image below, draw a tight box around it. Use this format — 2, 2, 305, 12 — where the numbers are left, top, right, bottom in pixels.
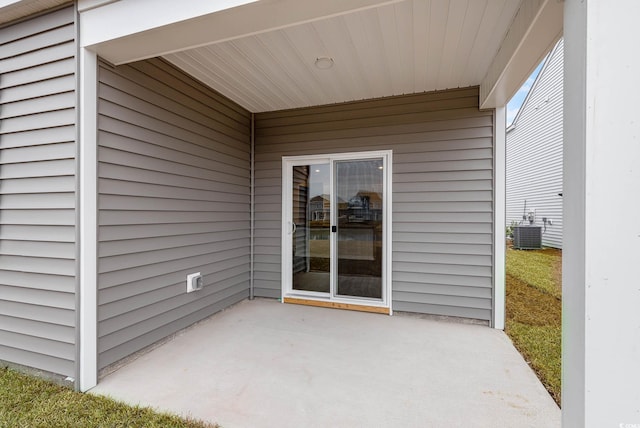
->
507, 40, 564, 248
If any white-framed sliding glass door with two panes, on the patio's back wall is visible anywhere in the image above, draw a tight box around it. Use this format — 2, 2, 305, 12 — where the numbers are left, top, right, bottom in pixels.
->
282, 152, 390, 305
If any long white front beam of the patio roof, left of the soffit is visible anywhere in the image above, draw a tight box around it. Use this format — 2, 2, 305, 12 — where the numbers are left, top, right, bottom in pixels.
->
79, 0, 401, 65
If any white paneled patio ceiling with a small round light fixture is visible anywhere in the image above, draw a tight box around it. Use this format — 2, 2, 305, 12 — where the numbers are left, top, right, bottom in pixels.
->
164, 0, 520, 112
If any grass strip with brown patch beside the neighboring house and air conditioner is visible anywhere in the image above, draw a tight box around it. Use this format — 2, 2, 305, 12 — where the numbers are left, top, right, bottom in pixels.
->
505, 248, 562, 405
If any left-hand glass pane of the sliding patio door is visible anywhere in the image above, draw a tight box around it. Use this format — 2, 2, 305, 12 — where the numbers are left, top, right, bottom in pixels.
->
291, 164, 331, 293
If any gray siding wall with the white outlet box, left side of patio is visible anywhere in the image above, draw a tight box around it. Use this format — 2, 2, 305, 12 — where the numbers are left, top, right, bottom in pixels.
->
98, 59, 250, 368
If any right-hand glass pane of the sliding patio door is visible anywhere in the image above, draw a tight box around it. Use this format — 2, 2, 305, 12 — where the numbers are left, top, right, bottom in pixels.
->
335, 159, 384, 299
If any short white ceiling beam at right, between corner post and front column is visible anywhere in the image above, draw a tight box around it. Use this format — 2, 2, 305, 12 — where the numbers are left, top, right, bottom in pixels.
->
480, 0, 564, 109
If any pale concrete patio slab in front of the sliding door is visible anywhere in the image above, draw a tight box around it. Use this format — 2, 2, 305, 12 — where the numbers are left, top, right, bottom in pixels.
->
91, 299, 560, 428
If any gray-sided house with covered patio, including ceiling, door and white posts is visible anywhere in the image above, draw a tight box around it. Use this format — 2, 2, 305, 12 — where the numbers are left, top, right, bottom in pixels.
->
0, 0, 640, 426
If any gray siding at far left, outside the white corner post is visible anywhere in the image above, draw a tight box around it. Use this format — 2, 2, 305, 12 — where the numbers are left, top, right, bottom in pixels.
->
0, 8, 76, 376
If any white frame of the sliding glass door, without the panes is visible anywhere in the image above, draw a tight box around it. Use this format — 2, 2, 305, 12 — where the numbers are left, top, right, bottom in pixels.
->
281, 150, 393, 313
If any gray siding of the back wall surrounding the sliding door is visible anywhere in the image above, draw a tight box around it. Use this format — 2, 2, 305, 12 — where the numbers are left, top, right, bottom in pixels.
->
254, 88, 494, 320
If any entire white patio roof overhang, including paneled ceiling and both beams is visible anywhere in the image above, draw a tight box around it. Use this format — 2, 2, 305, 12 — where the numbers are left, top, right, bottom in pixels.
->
78, 0, 563, 112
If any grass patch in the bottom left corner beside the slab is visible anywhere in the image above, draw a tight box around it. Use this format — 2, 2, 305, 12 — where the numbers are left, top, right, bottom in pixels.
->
0, 368, 217, 428
